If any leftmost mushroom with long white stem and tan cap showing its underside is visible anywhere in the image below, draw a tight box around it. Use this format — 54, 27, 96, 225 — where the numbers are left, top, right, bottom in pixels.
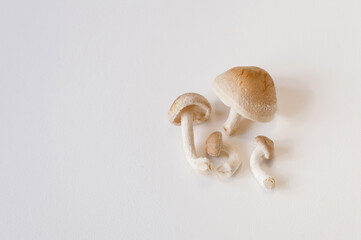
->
168, 93, 212, 174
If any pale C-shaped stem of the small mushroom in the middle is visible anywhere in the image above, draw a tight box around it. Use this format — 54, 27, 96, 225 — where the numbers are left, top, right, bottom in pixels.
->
216, 142, 241, 177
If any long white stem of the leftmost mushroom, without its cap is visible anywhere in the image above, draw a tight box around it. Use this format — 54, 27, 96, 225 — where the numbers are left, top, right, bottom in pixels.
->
181, 112, 212, 174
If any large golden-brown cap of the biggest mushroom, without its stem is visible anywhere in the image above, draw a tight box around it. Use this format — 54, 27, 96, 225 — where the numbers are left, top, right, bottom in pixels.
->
213, 67, 277, 122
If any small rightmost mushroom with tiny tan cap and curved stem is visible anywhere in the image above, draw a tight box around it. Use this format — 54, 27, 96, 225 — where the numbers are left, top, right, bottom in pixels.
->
250, 136, 275, 189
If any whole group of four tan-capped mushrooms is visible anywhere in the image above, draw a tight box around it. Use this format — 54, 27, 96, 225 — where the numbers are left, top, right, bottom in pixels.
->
168, 67, 277, 189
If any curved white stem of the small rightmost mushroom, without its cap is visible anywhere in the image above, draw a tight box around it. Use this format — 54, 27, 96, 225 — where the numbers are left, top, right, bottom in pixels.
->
250, 146, 275, 189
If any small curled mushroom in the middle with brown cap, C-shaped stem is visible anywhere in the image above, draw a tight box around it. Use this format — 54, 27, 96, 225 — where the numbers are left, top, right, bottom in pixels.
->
206, 131, 241, 177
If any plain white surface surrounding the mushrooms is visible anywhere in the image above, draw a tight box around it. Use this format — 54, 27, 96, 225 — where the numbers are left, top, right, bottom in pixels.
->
0, 0, 361, 240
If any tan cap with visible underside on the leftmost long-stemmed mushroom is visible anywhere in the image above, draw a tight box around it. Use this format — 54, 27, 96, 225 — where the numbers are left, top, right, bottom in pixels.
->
168, 93, 212, 125
